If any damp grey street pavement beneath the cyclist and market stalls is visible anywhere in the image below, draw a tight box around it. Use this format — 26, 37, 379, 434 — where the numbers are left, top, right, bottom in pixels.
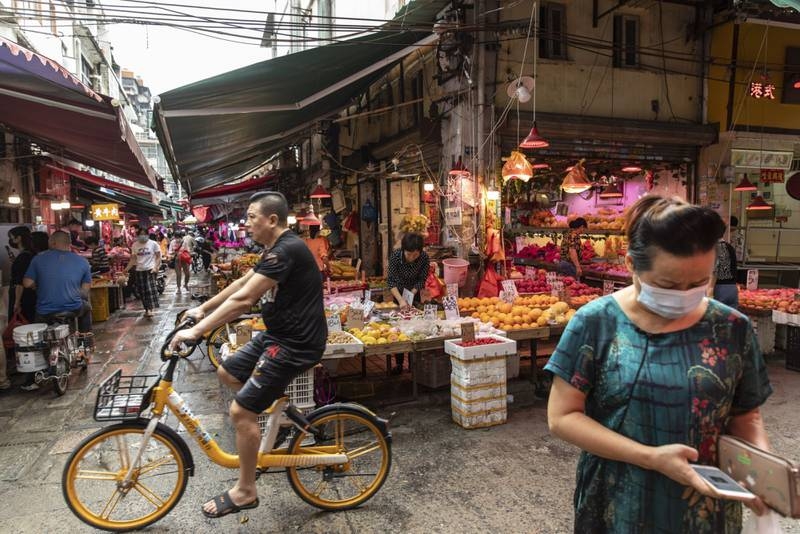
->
0, 281, 800, 533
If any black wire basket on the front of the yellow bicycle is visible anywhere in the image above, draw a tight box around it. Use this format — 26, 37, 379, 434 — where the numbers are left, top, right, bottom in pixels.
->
94, 369, 159, 421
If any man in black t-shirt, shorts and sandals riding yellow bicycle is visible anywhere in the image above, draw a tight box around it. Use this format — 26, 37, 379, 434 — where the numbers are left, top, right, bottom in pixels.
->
170, 191, 328, 518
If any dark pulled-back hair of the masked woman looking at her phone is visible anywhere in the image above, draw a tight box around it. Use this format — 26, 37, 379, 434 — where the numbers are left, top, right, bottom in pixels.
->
625, 195, 725, 271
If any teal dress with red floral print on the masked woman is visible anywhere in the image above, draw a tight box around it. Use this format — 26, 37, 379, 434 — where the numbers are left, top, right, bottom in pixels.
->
545, 295, 772, 534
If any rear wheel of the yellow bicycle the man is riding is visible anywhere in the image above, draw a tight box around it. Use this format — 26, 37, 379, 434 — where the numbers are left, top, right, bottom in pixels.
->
286, 408, 392, 511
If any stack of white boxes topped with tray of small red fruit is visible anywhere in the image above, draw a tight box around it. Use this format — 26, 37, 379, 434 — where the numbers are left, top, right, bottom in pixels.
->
444, 335, 517, 428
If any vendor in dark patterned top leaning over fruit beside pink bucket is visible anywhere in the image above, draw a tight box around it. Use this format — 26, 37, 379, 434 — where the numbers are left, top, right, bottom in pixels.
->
386, 233, 430, 374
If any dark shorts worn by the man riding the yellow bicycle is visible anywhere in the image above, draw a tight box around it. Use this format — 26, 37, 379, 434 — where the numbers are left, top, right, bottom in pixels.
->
222, 332, 319, 413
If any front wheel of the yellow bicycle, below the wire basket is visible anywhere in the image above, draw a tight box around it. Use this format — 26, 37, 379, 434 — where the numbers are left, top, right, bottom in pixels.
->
61, 420, 188, 532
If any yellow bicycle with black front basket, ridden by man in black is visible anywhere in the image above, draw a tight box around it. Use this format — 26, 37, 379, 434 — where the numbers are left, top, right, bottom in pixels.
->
62, 323, 392, 532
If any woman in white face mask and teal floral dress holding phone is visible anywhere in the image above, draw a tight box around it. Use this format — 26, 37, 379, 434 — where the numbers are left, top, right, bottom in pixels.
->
545, 196, 772, 533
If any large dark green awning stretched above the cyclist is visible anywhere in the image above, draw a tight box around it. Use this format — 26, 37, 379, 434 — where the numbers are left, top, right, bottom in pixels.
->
153, 0, 448, 194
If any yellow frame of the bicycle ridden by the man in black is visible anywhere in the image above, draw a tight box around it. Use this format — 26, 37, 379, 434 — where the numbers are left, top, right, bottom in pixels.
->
151, 379, 348, 469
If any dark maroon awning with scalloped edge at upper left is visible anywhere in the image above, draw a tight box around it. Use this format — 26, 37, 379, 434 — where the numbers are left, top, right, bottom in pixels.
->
0, 37, 158, 191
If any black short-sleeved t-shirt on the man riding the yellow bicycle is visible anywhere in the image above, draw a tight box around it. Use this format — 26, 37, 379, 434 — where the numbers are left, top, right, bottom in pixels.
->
255, 232, 328, 358
